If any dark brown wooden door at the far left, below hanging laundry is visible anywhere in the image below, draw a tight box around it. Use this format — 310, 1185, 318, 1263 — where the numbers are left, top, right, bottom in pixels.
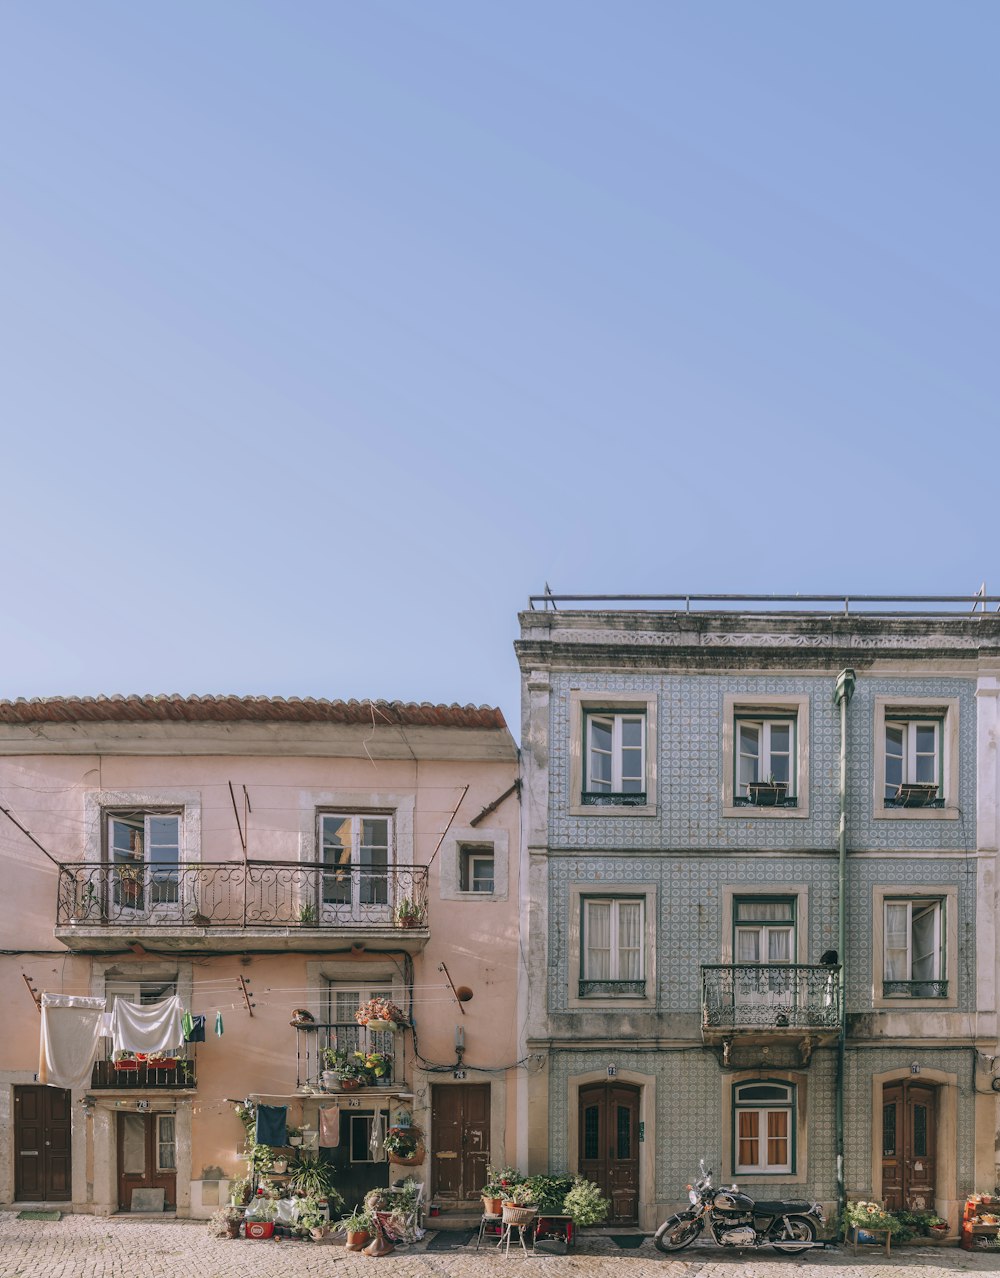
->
14, 1086, 73, 1203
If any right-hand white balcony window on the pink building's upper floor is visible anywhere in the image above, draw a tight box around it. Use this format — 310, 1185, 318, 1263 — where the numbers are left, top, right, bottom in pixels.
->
320, 813, 393, 923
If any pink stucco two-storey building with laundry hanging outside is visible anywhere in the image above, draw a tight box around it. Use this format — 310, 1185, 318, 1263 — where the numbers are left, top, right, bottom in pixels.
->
0, 697, 524, 1215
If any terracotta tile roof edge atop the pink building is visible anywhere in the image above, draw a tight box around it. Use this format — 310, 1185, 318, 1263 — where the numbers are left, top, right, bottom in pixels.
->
0, 693, 506, 731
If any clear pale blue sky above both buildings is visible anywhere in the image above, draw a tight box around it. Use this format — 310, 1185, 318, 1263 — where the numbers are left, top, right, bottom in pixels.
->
0, 0, 1000, 731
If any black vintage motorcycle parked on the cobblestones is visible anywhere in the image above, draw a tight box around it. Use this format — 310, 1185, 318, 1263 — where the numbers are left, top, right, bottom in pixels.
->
652, 1160, 824, 1255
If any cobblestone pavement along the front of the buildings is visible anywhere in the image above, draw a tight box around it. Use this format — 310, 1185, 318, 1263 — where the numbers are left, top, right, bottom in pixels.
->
0, 1212, 1000, 1278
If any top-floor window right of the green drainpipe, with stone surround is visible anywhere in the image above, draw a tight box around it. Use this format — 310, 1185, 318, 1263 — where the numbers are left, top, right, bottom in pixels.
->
872, 697, 960, 820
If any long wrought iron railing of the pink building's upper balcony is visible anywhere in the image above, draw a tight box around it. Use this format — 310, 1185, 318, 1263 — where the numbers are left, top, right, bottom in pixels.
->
56, 861, 427, 929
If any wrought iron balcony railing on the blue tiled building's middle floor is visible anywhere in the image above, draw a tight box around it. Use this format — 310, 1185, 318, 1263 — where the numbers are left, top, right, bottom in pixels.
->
701, 962, 840, 1030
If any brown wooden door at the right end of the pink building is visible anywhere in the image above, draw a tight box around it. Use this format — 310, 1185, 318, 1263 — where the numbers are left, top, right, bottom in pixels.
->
431, 1082, 490, 1203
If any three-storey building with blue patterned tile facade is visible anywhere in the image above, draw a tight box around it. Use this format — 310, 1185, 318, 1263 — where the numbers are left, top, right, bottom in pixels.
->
515, 599, 1000, 1228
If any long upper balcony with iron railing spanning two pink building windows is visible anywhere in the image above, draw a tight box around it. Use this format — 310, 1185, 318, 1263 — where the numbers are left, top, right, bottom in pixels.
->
55, 861, 430, 953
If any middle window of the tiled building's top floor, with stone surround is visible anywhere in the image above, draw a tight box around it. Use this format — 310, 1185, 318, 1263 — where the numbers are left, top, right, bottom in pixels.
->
721, 693, 809, 819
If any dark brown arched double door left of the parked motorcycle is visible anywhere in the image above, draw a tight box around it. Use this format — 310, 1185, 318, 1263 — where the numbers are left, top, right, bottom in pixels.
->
579, 1082, 639, 1224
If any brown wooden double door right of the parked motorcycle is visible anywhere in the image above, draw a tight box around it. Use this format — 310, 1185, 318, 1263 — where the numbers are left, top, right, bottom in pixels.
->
882, 1080, 937, 1212
